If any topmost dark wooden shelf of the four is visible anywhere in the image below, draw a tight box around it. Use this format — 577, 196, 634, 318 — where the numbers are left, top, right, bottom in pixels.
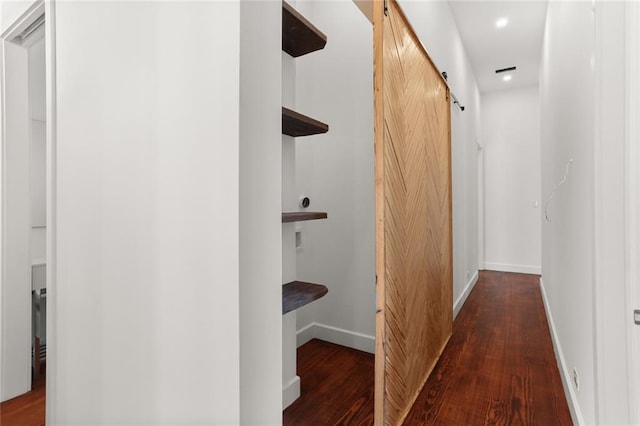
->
282, 1, 327, 58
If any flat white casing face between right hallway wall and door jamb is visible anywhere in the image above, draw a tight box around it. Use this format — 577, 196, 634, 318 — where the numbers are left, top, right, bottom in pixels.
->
592, 2, 631, 424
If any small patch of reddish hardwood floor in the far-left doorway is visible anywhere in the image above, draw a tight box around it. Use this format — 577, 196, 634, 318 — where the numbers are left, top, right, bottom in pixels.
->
0, 369, 46, 426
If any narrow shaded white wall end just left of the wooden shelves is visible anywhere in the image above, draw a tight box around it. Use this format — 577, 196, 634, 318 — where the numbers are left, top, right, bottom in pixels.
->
239, 1, 283, 424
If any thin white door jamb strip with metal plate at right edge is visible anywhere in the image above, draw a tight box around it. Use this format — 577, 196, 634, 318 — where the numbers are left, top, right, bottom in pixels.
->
624, 2, 640, 424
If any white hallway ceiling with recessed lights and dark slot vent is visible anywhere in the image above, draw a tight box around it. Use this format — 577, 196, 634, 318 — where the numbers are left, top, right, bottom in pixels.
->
449, 0, 547, 92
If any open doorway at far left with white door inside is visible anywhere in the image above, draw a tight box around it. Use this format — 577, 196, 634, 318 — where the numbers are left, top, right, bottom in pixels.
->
0, 1, 49, 420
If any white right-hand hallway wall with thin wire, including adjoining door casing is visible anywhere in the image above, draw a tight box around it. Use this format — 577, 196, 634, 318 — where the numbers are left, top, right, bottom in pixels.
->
540, 2, 631, 424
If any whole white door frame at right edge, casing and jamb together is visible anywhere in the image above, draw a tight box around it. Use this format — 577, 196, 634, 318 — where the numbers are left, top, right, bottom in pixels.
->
593, 2, 640, 424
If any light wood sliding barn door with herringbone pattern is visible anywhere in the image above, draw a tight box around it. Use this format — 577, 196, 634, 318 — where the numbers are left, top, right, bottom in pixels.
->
374, 0, 453, 425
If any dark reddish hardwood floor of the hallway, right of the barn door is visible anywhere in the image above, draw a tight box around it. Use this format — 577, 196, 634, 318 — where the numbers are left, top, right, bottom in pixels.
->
405, 271, 572, 426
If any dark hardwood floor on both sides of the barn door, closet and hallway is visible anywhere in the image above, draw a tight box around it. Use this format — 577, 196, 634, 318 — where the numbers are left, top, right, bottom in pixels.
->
284, 271, 572, 426
